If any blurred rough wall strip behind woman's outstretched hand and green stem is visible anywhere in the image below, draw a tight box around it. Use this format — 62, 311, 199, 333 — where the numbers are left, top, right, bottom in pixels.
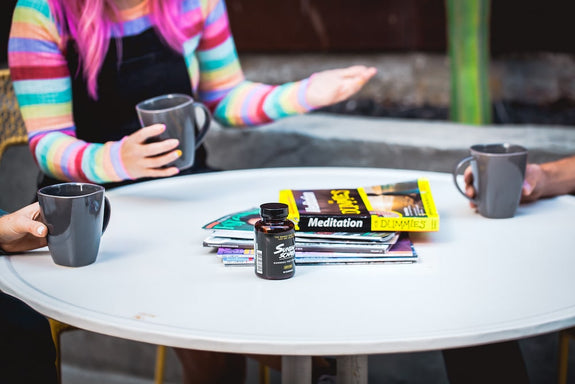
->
240, 52, 575, 107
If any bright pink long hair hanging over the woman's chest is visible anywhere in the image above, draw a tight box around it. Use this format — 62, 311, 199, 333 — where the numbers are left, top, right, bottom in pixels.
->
48, 0, 185, 99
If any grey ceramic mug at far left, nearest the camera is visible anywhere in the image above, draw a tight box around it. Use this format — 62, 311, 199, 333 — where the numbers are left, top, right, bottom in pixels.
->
37, 183, 111, 267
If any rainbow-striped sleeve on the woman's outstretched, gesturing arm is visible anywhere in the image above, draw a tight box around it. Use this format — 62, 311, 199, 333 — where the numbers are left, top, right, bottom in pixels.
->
192, 0, 312, 126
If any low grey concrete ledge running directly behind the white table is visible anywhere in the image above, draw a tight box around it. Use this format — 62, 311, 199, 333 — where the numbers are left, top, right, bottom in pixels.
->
202, 113, 575, 172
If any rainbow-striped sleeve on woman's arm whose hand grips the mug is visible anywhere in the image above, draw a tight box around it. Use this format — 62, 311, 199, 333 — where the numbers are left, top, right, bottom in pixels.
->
8, 0, 127, 183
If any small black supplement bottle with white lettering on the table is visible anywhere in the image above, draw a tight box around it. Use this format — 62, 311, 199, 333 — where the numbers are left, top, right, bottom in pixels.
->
254, 203, 295, 280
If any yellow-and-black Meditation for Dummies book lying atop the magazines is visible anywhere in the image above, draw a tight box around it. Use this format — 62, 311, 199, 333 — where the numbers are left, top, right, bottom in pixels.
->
279, 178, 439, 233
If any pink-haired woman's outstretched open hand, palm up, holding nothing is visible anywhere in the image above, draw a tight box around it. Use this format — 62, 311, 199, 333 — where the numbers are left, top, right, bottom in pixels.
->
306, 65, 377, 107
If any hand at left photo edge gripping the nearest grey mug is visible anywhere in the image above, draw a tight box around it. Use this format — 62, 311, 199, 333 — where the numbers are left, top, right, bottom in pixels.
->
0, 203, 48, 254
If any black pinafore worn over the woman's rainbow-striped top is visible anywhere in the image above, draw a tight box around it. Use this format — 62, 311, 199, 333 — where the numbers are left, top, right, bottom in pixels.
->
39, 28, 210, 188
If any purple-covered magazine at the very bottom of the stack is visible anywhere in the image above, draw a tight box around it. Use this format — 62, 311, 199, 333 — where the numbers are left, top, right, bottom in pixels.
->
217, 235, 418, 265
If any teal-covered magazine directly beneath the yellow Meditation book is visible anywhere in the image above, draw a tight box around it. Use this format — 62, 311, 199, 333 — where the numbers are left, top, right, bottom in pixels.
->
202, 208, 395, 242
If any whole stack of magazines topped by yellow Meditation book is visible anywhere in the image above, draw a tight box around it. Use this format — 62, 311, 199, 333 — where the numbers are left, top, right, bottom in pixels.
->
203, 179, 439, 265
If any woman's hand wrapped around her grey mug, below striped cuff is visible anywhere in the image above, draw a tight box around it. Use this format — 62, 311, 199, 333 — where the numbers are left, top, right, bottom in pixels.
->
121, 124, 182, 179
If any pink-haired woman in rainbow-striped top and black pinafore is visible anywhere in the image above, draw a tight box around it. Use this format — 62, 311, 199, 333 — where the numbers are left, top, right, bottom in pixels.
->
8, 0, 376, 190
